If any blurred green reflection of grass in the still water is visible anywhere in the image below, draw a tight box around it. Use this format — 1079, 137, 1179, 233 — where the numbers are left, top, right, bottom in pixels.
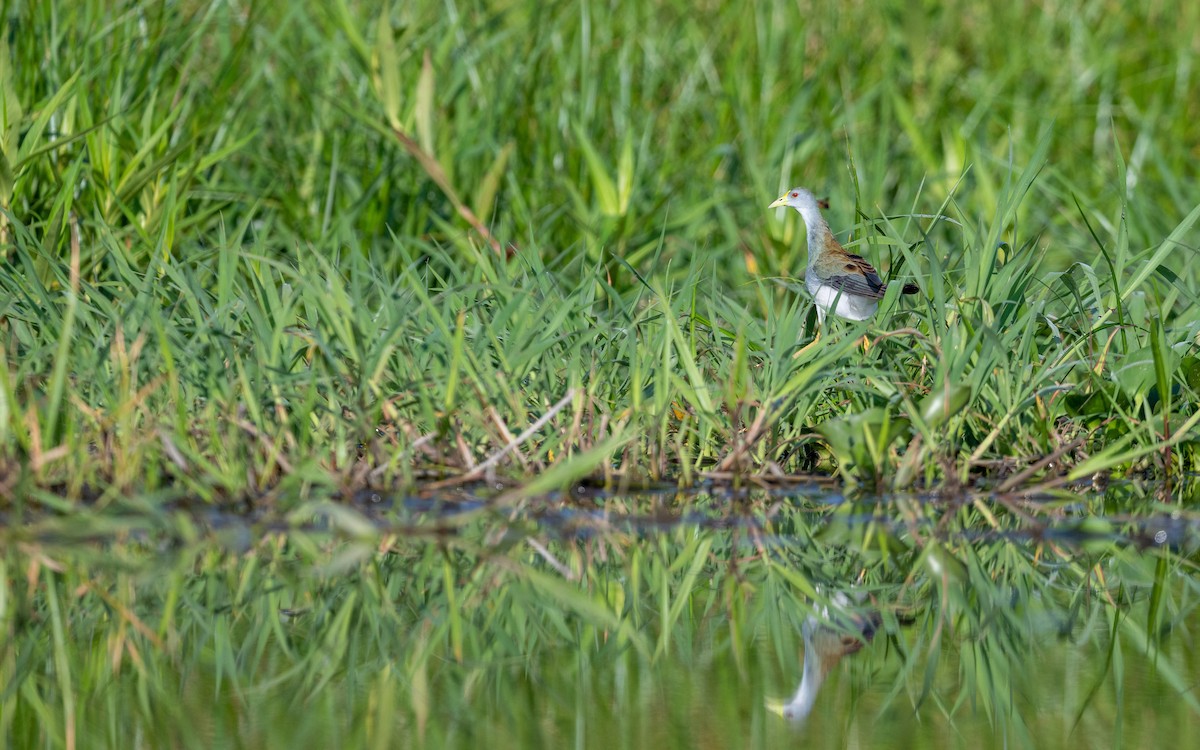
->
0, 482, 1200, 746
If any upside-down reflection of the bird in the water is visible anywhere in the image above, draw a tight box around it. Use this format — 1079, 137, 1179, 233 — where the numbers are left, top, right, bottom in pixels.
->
768, 592, 883, 722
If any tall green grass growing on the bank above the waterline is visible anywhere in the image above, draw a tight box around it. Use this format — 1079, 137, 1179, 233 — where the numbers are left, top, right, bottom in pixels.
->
0, 0, 1200, 504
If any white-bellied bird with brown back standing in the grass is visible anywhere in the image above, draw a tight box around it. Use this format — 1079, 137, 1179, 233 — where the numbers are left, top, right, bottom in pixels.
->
767, 187, 920, 324
